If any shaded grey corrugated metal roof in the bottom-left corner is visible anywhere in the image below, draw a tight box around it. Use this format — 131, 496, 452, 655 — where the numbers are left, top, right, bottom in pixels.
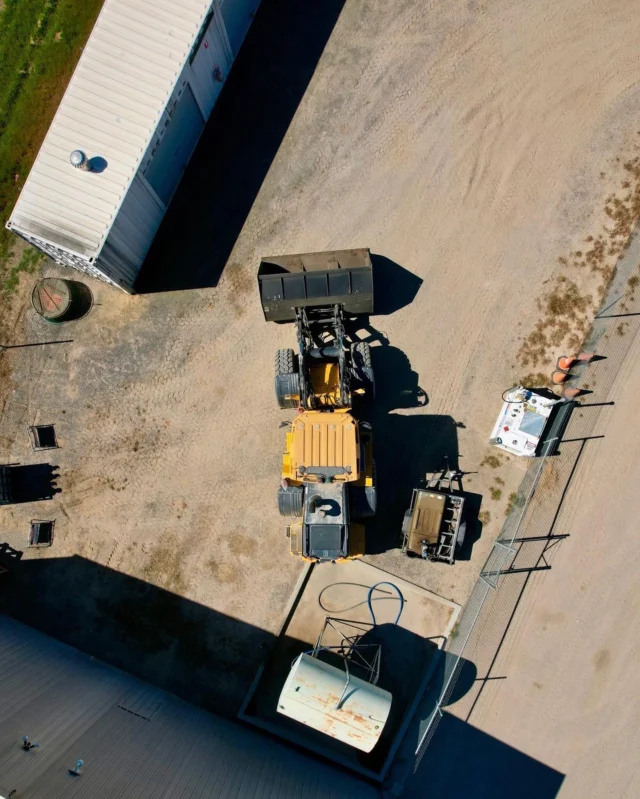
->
0, 616, 378, 799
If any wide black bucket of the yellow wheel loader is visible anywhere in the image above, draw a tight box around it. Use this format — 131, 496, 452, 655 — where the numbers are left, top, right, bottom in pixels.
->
258, 248, 373, 322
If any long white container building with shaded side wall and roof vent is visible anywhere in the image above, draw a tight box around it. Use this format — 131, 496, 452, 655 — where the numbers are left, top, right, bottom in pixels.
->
7, 0, 260, 291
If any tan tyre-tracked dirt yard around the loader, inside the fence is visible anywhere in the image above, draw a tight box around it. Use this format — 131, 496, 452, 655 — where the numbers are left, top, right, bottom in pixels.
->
0, 0, 640, 720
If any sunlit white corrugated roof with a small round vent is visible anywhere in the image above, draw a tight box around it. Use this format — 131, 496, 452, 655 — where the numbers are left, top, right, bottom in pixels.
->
9, 0, 211, 258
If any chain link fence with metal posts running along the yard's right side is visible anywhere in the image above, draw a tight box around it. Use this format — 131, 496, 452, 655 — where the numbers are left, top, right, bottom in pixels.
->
414, 228, 640, 771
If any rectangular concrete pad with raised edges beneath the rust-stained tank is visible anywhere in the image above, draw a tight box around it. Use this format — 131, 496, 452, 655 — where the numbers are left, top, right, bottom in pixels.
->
240, 561, 461, 780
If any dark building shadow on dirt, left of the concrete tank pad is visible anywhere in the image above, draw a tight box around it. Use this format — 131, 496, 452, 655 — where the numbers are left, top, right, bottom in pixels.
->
0, 545, 275, 718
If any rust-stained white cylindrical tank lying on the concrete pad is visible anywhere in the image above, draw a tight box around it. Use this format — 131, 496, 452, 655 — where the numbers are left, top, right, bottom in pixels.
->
278, 654, 391, 752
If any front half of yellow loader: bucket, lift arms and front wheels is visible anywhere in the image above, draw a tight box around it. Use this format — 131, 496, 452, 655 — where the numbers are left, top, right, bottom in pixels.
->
258, 249, 374, 410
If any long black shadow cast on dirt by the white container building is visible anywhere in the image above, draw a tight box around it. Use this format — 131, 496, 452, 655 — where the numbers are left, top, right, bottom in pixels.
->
135, 0, 344, 293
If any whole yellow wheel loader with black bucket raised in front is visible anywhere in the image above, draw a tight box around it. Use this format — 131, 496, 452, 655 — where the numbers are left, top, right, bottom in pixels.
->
258, 249, 376, 562
